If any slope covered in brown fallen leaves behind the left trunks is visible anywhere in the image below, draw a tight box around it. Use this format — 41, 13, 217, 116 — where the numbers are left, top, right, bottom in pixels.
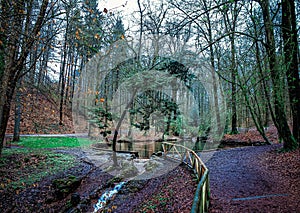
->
6, 89, 74, 134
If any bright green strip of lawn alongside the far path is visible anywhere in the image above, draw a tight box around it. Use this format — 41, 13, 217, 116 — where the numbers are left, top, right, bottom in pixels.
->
17, 137, 95, 149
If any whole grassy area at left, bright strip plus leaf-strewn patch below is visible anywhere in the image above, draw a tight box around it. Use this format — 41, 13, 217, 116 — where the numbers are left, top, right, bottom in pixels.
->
0, 137, 96, 191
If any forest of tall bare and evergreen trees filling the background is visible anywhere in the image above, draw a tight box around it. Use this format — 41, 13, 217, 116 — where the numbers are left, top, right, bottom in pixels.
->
0, 0, 300, 211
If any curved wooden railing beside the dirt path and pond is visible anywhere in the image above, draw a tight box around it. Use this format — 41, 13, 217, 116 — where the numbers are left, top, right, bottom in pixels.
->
162, 142, 210, 213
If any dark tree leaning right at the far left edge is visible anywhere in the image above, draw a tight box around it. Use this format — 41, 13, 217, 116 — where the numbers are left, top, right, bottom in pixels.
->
0, 0, 49, 154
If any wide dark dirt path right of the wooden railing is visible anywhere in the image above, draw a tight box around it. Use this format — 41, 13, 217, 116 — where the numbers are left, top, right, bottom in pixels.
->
201, 145, 300, 212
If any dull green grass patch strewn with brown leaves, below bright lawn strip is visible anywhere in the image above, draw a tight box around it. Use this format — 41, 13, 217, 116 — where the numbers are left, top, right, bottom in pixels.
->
0, 149, 77, 190
